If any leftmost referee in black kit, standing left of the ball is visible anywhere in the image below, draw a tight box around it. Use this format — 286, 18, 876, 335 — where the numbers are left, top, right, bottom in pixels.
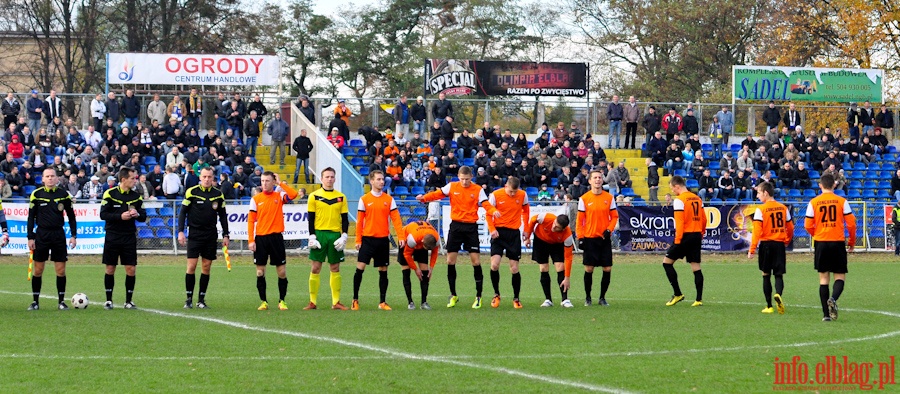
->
28, 168, 78, 311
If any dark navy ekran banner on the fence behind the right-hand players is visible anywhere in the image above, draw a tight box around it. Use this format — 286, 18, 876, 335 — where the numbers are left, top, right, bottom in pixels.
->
618, 205, 756, 252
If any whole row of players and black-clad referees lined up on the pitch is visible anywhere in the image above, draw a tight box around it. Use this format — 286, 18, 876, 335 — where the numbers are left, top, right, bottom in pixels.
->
21, 167, 855, 319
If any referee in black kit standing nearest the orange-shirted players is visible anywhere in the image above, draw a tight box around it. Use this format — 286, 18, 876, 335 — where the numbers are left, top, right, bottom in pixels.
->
178, 167, 228, 309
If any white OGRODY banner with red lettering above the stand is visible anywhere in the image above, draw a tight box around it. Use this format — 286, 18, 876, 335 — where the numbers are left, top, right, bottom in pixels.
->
106, 53, 281, 86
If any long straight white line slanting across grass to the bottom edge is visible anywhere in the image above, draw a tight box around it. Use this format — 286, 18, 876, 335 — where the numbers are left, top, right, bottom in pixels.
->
0, 290, 631, 394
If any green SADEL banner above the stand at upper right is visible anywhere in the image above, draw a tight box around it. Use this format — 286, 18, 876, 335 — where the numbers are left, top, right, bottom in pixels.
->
732, 66, 884, 103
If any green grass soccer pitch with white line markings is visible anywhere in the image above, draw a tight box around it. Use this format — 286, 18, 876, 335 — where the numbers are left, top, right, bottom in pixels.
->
0, 254, 900, 393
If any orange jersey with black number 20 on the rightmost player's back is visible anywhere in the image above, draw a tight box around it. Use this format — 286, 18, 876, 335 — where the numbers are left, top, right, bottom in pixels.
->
805, 192, 856, 245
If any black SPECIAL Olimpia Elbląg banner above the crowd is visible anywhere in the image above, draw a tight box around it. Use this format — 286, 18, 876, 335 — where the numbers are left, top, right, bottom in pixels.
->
425, 59, 588, 97
